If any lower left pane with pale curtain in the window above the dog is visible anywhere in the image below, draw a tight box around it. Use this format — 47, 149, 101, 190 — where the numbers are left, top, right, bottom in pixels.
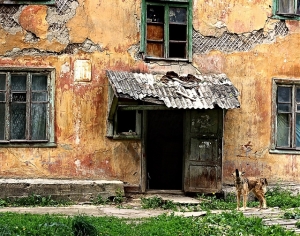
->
277, 114, 291, 147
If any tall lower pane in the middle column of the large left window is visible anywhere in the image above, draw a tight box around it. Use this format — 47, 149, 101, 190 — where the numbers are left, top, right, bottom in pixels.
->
10, 103, 26, 139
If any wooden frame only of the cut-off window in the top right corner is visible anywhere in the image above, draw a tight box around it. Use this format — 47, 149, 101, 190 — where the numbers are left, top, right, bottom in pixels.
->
272, 0, 300, 20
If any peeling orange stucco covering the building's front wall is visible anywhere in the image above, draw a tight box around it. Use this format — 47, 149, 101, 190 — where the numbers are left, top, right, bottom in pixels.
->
0, 0, 300, 188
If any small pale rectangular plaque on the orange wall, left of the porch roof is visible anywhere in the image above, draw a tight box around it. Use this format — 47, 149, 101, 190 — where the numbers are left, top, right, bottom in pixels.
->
74, 60, 92, 82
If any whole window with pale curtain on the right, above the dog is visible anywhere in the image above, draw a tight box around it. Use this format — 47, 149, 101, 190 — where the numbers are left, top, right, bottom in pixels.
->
273, 79, 300, 150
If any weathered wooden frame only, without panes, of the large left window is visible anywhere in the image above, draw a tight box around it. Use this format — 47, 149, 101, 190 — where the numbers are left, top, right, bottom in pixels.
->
0, 67, 56, 147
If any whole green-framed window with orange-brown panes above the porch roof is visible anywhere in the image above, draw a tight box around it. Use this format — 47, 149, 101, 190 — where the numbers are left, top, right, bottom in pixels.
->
141, 0, 192, 60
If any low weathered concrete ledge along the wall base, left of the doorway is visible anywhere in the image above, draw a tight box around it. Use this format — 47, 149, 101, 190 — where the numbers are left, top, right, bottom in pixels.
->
0, 179, 124, 202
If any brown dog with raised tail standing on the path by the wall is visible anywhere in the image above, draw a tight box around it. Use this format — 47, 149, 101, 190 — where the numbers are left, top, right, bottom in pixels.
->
232, 169, 268, 210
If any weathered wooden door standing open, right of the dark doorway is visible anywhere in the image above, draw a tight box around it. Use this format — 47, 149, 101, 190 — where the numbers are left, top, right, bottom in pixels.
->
184, 109, 223, 193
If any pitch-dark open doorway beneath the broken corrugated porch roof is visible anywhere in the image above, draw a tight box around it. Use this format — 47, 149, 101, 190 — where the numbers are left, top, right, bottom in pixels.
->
146, 110, 183, 190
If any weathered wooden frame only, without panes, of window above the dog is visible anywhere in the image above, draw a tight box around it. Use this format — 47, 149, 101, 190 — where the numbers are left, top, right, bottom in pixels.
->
270, 78, 300, 154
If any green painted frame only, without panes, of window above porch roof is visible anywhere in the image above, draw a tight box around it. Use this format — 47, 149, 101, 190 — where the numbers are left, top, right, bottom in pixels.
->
140, 0, 193, 62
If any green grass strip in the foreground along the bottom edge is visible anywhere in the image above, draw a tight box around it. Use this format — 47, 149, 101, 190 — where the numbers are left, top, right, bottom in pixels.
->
0, 211, 295, 236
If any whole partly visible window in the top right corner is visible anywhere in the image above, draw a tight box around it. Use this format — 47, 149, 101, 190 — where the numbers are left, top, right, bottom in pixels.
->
273, 0, 300, 20
